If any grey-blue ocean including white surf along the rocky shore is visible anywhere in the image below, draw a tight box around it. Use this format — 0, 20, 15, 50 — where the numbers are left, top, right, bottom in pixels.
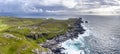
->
61, 16, 120, 54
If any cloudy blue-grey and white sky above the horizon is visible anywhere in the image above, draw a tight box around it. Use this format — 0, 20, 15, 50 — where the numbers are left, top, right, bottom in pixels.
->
0, 0, 120, 17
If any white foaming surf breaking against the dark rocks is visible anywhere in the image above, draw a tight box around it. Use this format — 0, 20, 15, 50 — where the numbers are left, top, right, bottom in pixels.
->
61, 24, 92, 54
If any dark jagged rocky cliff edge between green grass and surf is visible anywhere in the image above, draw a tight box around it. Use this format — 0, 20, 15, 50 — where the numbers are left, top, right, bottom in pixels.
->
42, 18, 85, 54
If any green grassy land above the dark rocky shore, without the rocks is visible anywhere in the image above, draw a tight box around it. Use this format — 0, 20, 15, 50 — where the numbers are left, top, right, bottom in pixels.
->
0, 17, 75, 54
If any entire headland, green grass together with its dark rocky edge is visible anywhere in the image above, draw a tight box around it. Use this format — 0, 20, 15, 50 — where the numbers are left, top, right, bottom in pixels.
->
0, 17, 85, 54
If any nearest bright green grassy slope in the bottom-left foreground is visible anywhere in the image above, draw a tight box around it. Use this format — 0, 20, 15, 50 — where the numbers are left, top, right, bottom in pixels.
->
0, 37, 45, 54
